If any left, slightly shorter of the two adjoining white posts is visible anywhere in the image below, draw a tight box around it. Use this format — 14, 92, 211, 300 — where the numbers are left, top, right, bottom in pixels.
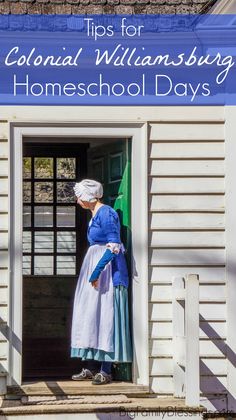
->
172, 277, 185, 398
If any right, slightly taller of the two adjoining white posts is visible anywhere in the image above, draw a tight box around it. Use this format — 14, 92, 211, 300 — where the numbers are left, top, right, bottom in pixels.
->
185, 274, 200, 407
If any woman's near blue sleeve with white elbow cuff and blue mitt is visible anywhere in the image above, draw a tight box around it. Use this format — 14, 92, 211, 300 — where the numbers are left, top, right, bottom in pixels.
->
89, 207, 121, 282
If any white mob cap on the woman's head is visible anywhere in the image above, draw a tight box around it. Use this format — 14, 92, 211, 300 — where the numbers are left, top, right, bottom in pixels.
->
74, 179, 103, 203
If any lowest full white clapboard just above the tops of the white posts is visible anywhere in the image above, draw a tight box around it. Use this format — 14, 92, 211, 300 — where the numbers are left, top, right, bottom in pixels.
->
150, 249, 225, 265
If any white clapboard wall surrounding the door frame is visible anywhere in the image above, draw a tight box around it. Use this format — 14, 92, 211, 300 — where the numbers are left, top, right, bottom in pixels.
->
0, 107, 227, 395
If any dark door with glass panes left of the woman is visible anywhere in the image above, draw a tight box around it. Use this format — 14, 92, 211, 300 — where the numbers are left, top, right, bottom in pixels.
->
22, 140, 88, 381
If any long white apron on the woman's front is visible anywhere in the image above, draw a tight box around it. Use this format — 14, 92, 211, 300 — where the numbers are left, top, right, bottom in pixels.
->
71, 245, 114, 352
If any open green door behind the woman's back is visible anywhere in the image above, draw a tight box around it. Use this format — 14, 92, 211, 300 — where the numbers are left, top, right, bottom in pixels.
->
88, 139, 132, 381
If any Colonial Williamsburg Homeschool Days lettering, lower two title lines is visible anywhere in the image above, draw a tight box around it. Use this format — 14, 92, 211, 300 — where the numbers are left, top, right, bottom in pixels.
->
5, 44, 234, 102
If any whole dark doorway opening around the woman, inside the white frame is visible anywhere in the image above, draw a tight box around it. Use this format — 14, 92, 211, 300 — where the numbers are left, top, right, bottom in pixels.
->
22, 138, 131, 381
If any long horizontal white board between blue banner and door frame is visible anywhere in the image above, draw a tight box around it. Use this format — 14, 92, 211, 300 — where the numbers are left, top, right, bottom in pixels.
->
0, 105, 225, 124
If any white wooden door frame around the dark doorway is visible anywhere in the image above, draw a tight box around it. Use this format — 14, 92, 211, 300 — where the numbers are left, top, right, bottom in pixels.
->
7, 122, 149, 386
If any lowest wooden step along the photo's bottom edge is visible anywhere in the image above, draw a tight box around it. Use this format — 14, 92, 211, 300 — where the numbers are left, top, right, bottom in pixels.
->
0, 396, 205, 420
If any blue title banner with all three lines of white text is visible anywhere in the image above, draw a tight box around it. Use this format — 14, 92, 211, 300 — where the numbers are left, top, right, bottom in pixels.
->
0, 17, 235, 104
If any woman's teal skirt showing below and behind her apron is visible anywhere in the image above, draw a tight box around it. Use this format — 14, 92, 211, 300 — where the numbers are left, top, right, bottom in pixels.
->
71, 286, 132, 363
